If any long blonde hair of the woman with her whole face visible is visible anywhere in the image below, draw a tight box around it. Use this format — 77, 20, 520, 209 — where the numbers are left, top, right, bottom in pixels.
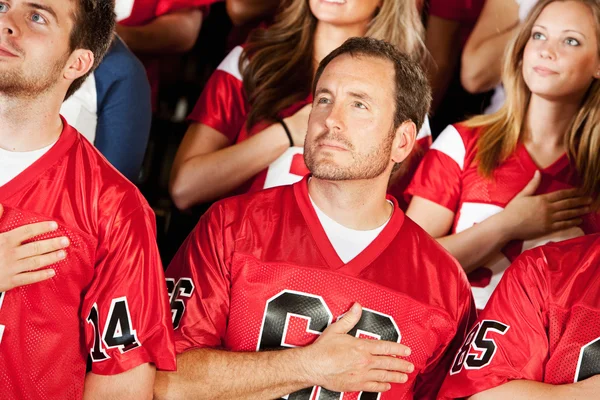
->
466, 0, 600, 202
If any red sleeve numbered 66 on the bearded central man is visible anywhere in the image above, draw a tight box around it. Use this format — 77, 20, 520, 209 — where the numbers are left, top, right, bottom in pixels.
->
166, 206, 230, 354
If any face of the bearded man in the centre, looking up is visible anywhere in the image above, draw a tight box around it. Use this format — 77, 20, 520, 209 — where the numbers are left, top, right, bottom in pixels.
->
304, 54, 395, 181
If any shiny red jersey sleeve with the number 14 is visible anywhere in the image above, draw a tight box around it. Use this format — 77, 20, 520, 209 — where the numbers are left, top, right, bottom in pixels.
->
81, 191, 175, 375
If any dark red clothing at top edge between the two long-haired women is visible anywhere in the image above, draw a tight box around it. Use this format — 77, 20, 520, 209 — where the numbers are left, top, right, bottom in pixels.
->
429, 0, 485, 47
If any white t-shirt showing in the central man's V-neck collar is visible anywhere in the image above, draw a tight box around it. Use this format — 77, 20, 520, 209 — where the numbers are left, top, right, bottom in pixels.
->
309, 196, 392, 264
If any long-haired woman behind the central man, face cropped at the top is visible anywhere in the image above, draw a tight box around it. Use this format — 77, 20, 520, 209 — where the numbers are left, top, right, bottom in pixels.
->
170, 0, 430, 209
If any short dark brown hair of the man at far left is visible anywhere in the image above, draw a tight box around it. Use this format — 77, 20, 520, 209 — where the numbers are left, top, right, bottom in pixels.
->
65, 0, 116, 99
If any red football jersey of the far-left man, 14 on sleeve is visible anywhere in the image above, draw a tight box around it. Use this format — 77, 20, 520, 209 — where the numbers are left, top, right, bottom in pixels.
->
0, 119, 175, 400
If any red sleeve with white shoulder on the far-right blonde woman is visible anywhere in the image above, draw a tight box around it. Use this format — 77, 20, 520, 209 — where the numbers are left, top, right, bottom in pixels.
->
404, 125, 466, 213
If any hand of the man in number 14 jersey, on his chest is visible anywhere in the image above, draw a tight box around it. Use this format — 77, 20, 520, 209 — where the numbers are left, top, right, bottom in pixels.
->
0, 205, 69, 292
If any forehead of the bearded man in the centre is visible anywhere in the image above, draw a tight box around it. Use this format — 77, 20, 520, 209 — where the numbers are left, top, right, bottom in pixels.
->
317, 54, 396, 96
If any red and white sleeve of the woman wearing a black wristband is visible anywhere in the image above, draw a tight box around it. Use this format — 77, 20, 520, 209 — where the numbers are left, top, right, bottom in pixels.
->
189, 46, 248, 143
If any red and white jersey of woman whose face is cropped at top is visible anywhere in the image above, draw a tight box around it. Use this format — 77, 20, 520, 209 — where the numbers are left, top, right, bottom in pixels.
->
189, 46, 431, 205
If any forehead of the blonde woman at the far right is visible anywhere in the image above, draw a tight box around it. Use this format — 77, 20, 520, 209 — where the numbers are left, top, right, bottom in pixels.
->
535, 1, 597, 38
